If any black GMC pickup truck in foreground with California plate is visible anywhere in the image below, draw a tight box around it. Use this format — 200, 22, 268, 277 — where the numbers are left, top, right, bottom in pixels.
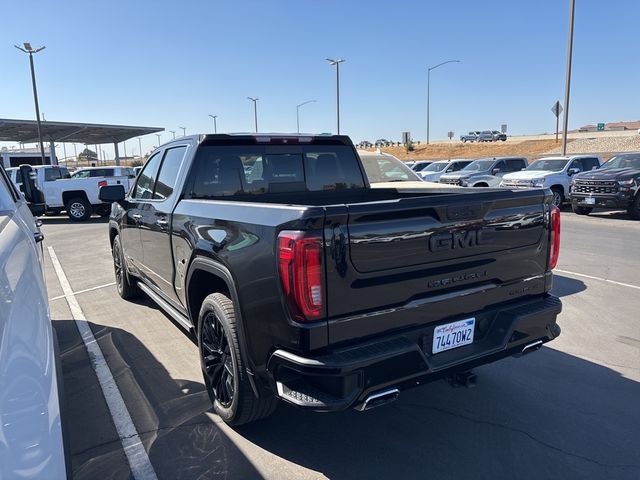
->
100, 134, 561, 425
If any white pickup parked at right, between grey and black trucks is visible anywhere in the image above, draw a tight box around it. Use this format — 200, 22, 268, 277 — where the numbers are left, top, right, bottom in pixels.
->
500, 155, 602, 207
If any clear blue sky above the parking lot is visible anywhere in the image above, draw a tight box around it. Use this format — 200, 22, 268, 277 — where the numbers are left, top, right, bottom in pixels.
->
0, 0, 640, 157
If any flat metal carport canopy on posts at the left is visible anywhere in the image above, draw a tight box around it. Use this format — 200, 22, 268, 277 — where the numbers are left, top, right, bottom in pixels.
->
0, 118, 164, 164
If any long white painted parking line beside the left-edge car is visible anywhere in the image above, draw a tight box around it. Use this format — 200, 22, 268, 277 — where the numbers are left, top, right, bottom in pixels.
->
47, 247, 158, 480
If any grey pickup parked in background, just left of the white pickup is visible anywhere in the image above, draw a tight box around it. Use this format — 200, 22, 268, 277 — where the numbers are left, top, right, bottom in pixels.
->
440, 157, 527, 187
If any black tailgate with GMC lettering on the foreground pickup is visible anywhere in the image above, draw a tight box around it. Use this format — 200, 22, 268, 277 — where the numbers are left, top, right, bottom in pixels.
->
325, 190, 550, 343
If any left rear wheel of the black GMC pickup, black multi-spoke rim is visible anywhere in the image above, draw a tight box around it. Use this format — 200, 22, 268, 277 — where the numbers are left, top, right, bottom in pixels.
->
198, 293, 278, 425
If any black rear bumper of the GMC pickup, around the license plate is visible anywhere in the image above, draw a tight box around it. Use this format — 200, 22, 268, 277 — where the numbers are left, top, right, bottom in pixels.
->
267, 295, 562, 411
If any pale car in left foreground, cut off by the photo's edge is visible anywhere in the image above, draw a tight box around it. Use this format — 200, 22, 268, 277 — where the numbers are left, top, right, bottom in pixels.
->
0, 166, 67, 479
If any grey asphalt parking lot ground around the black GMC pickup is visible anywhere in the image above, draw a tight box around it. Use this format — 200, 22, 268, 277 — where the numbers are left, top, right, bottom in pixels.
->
43, 212, 640, 479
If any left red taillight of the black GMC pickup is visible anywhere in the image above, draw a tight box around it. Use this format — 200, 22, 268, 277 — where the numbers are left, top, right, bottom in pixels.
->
278, 231, 324, 322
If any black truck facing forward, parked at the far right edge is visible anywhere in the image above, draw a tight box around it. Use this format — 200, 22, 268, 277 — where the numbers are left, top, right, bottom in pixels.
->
569, 152, 640, 220
